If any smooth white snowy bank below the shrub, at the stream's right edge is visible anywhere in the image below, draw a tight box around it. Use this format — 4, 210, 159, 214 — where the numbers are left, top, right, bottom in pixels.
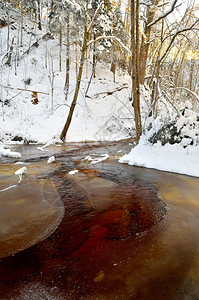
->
119, 143, 199, 177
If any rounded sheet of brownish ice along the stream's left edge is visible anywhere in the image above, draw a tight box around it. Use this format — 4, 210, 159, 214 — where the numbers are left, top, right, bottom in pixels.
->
0, 163, 64, 258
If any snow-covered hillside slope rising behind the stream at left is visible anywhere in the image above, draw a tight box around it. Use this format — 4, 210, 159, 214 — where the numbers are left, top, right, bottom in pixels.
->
0, 10, 134, 143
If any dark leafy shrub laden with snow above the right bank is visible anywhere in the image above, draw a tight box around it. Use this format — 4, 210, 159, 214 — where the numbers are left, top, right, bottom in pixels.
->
146, 105, 199, 147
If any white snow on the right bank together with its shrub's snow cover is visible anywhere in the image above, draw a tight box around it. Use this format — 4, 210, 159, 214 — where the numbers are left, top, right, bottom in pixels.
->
119, 106, 199, 177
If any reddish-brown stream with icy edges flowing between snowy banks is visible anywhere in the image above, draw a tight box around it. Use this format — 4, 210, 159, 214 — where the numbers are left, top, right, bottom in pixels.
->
0, 142, 199, 300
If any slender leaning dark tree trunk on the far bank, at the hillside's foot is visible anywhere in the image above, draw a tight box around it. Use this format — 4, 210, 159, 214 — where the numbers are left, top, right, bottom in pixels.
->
60, 4, 88, 141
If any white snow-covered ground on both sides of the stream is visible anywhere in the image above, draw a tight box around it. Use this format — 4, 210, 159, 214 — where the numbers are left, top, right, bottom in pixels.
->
0, 6, 199, 177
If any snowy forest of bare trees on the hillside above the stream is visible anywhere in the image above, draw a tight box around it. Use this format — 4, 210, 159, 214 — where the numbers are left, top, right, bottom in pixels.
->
1, 0, 199, 162
